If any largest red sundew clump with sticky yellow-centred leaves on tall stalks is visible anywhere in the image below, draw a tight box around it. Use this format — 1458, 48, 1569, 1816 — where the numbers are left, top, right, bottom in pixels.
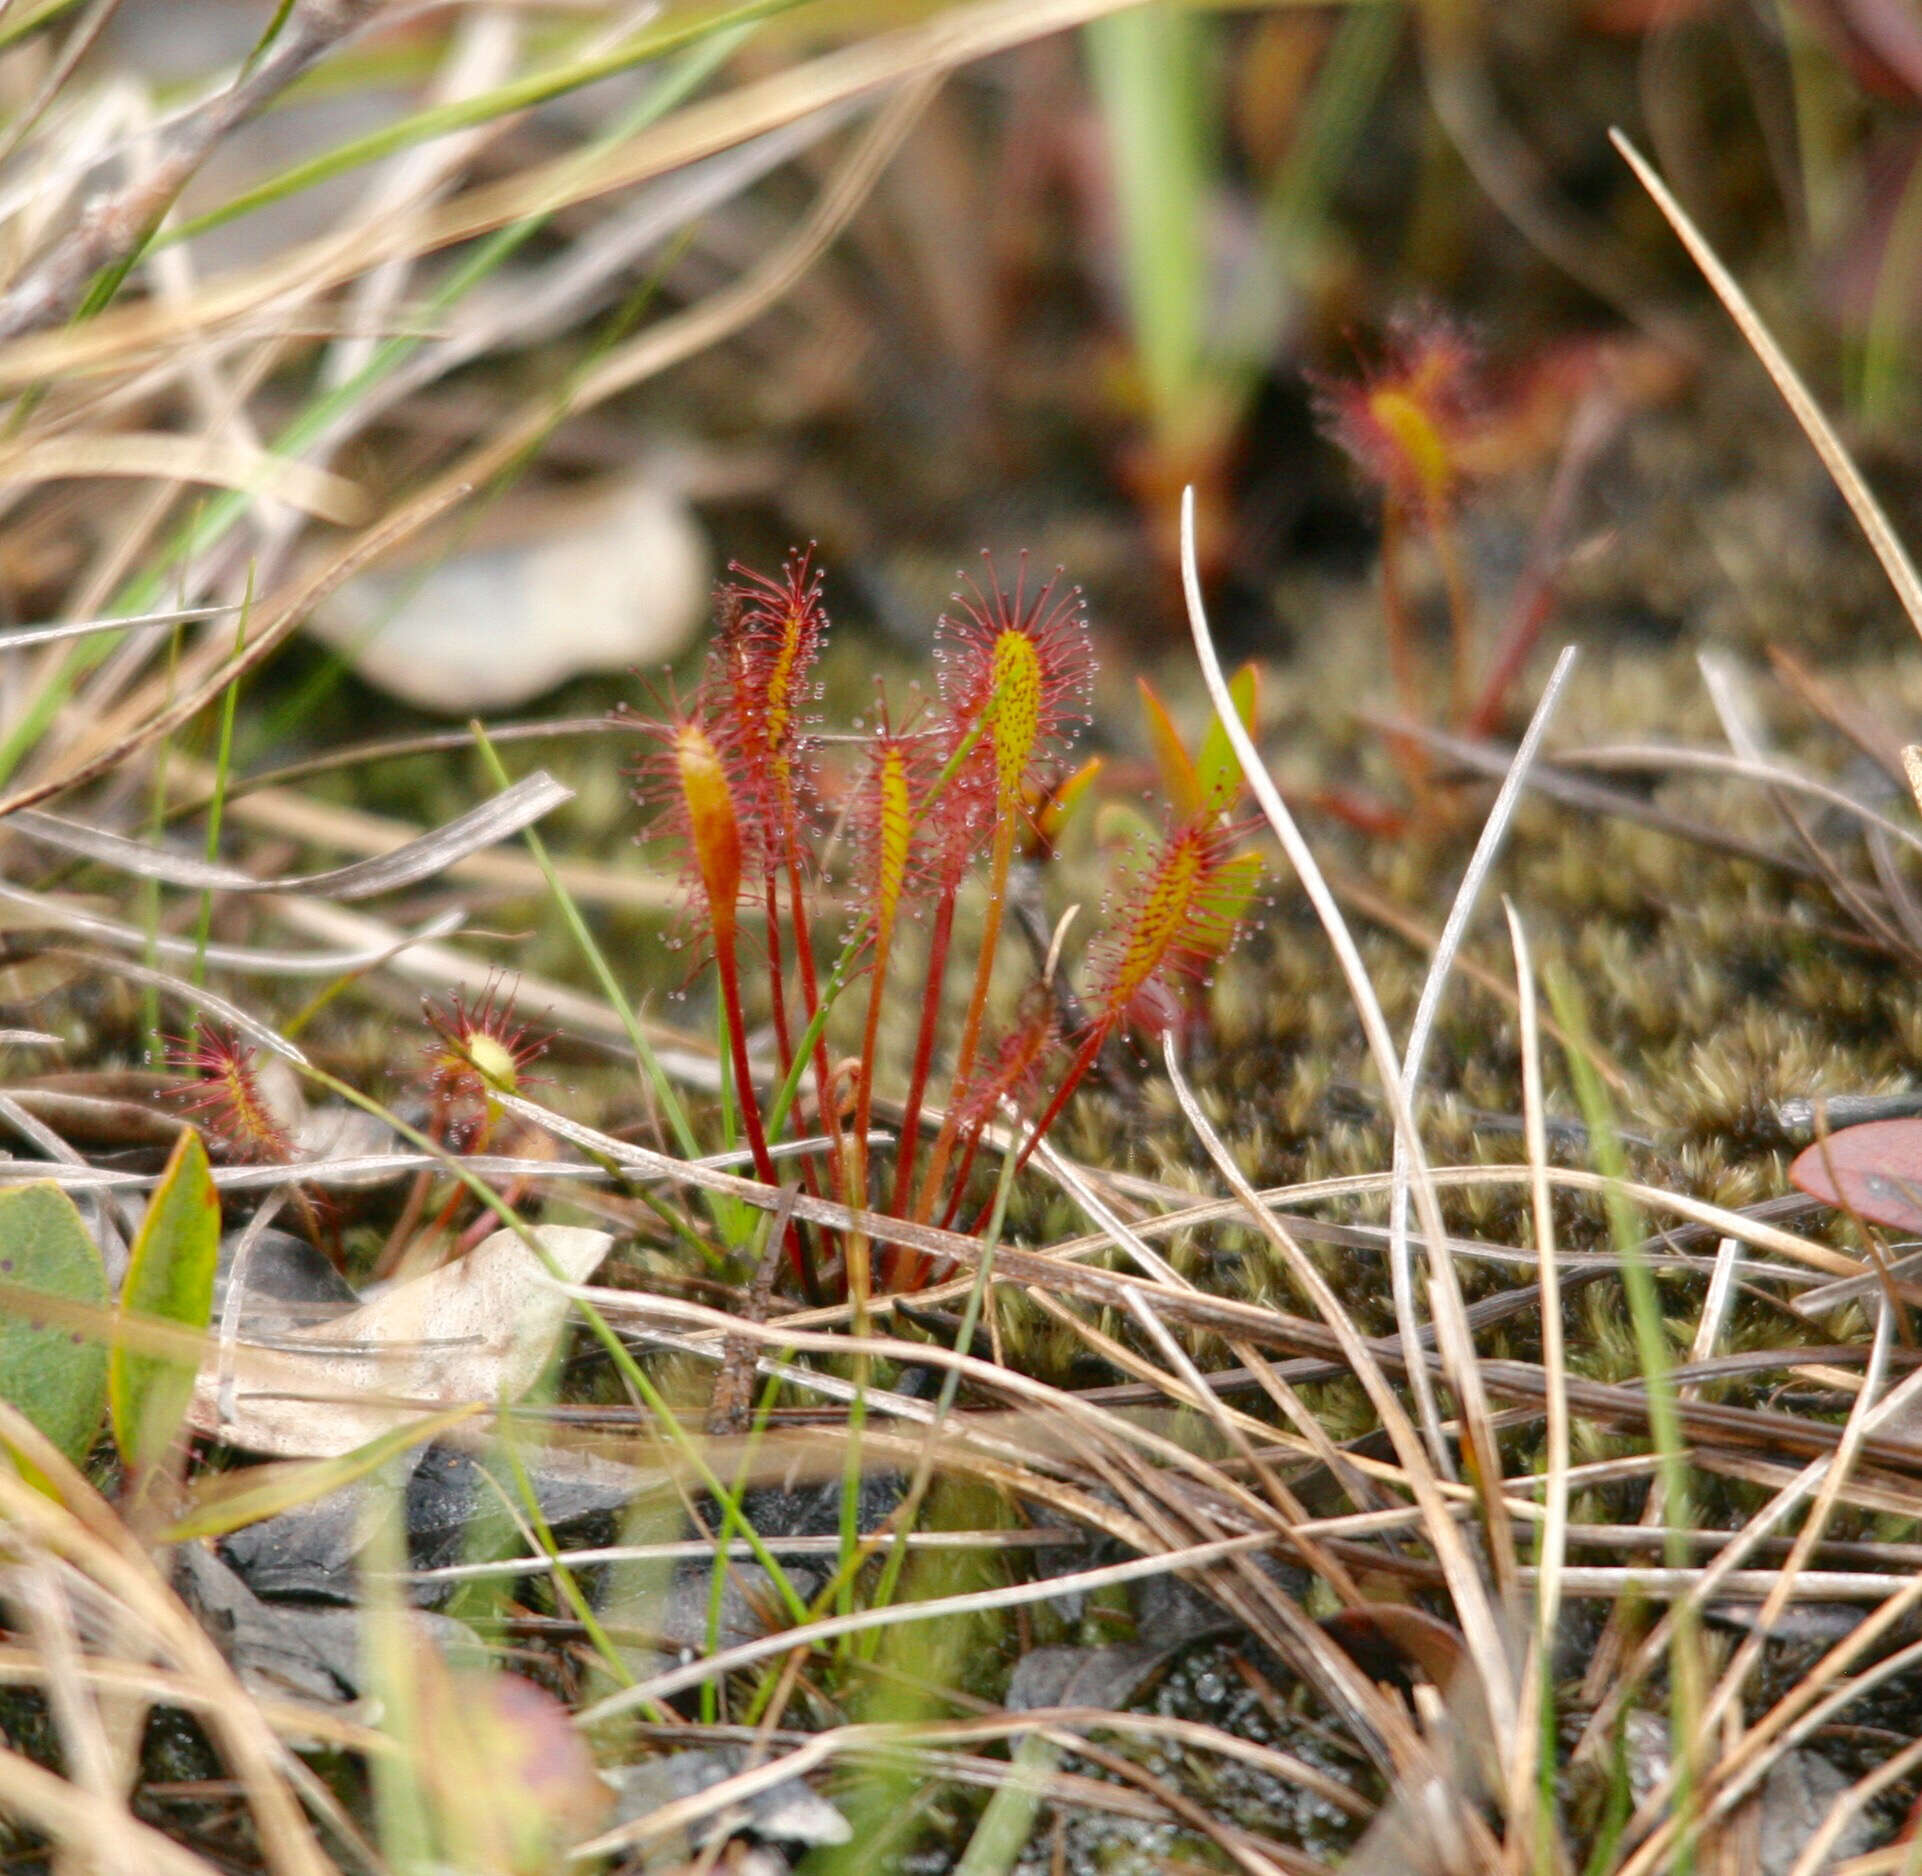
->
638, 554, 1259, 1299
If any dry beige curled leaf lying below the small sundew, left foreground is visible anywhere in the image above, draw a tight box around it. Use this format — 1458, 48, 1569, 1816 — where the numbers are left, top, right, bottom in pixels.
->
190, 1224, 613, 1459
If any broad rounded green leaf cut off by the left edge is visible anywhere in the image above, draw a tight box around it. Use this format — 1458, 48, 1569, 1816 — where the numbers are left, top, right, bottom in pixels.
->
0, 1184, 108, 1465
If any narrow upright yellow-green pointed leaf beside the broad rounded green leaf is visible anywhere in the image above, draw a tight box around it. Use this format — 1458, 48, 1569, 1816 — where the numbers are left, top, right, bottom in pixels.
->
108, 1132, 221, 1469
